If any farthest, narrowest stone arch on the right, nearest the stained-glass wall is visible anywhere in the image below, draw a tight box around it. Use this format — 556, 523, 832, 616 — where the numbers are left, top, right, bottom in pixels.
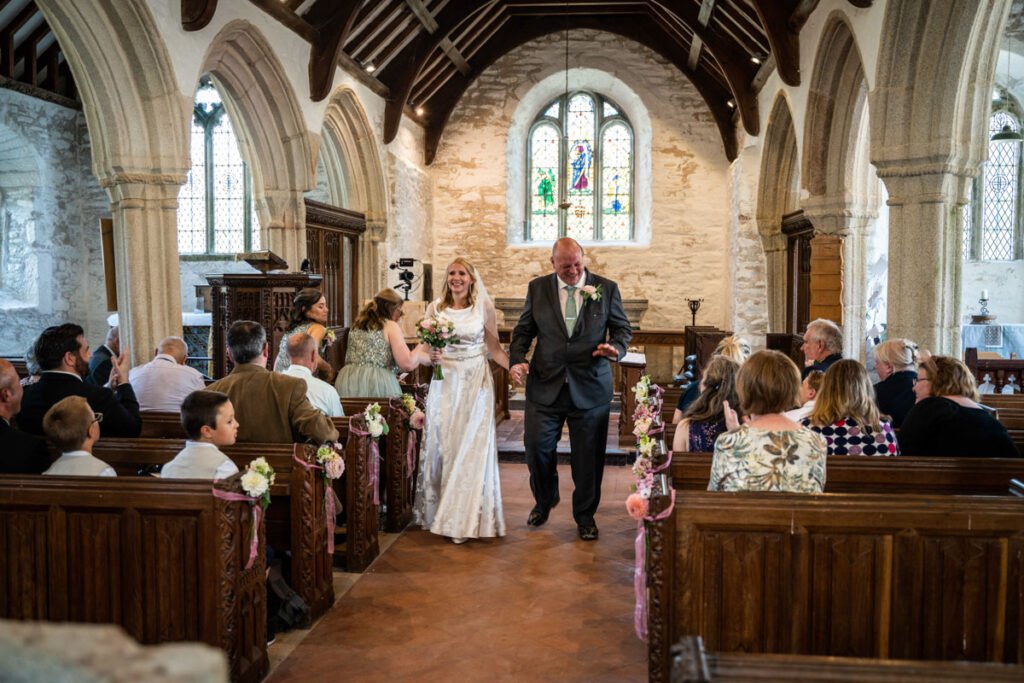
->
757, 91, 800, 332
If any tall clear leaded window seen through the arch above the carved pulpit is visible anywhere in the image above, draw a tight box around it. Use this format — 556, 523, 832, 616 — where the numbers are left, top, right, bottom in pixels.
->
178, 78, 260, 254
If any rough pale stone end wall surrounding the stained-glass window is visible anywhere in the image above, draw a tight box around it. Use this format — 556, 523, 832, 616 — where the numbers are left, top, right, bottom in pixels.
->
430, 31, 731, 329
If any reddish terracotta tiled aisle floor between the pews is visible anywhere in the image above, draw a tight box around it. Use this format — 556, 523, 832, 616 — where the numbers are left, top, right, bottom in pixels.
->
267, 464, 647, 683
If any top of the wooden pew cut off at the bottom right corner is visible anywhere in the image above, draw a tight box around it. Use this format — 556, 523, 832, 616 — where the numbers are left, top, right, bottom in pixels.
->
671, 637, 1024, 683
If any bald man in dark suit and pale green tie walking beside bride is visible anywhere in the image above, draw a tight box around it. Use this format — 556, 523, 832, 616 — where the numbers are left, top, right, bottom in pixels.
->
509, 238, 633, 541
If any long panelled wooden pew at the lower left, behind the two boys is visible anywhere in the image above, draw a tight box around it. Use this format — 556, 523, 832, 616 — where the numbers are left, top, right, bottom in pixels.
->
0, 475, 268, 683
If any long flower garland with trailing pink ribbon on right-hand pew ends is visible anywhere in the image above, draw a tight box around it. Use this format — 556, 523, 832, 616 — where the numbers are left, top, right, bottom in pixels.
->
626, 375, 676, 642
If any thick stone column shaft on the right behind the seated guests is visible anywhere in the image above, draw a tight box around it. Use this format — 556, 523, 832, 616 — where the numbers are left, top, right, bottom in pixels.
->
879, 168, 970, 357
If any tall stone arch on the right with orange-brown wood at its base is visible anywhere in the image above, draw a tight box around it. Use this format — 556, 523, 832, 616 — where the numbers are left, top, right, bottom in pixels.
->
802, 10, 879, 358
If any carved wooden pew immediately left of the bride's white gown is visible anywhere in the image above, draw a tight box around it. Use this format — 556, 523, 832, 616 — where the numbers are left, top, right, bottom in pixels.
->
334, 397, 420, 533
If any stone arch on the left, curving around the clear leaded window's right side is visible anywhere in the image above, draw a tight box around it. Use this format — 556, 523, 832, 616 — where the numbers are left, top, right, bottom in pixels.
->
196, 19, 317, 268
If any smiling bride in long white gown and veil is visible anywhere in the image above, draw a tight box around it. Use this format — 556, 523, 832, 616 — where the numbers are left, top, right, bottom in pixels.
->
413, 257, 509, 544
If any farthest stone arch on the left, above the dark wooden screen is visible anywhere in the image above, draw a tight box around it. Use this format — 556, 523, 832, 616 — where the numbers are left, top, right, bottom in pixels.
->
321, 88, 388, 297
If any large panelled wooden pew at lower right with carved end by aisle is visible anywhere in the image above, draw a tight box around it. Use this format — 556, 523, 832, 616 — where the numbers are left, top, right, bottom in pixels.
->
647, 490, 1024, 681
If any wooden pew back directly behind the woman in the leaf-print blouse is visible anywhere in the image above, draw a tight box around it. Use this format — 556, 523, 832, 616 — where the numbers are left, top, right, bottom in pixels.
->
670, 453, 1024, 496
